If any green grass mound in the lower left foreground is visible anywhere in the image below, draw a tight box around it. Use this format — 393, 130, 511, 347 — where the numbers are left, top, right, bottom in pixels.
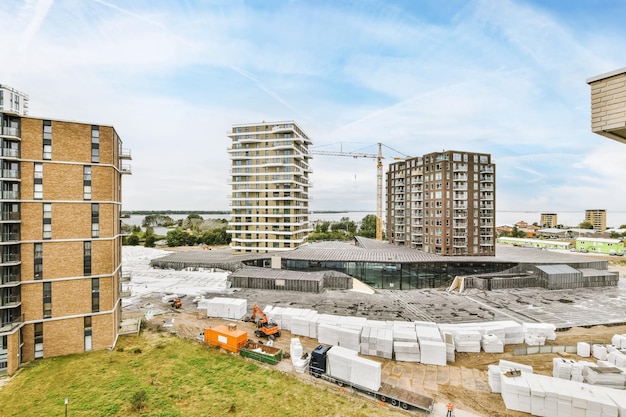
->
0, 331, 406, 417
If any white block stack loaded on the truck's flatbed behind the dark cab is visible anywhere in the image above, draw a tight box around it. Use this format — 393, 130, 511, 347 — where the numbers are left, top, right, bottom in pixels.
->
327, 346, 381, 391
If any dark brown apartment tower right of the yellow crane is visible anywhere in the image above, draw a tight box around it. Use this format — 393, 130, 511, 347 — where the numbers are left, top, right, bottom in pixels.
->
386, 151, 496, 256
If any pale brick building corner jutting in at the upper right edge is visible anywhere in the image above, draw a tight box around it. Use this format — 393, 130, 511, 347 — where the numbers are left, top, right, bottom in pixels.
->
587, 68, 626, 143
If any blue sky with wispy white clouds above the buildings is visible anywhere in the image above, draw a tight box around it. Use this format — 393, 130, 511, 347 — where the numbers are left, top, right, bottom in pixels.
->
0, 0, 626, 213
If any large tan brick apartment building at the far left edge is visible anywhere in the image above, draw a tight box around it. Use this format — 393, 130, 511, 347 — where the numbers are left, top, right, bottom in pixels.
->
0, 86, 130, 374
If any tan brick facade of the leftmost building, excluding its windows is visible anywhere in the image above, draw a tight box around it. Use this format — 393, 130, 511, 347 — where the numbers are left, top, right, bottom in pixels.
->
0, 117, 128, 374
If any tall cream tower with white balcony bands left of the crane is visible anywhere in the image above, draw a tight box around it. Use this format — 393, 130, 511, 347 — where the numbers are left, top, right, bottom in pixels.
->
228, 121, 312, 253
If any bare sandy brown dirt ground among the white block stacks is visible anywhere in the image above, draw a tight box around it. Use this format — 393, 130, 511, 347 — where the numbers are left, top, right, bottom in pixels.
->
141, 293, 626, 417
